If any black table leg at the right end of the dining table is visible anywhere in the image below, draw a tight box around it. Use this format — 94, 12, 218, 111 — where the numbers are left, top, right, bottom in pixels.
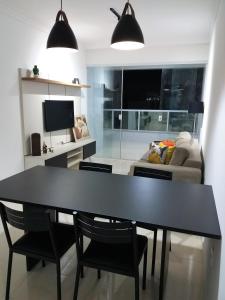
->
159, 230, 171, 300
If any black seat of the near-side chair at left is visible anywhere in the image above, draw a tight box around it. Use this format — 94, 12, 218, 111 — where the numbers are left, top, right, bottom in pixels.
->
13, 223, 75, 260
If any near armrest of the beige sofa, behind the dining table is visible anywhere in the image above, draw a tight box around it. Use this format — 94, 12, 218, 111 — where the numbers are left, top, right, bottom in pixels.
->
128, 161, 202, 183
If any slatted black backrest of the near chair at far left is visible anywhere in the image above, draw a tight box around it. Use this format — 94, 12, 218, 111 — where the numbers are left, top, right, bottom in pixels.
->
0, 202, 57, 254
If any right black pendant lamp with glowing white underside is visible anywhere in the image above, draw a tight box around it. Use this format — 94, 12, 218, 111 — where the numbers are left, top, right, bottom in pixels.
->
110, 1, 144, 50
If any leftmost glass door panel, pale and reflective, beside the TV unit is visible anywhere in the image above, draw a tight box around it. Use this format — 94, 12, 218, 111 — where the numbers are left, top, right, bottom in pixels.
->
87, 67, 122, 159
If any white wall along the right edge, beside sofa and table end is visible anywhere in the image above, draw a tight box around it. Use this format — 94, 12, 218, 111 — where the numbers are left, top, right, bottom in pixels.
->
201, 0, 225, 300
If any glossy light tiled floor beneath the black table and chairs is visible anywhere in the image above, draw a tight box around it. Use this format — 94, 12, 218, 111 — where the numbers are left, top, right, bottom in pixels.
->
0, 161, 203, 300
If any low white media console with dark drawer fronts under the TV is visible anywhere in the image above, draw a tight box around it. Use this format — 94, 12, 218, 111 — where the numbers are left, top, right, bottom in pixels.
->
25, 138, 96, 169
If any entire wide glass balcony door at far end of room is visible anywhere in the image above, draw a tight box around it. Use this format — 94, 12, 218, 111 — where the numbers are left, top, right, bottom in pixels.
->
87, 67, 203, 160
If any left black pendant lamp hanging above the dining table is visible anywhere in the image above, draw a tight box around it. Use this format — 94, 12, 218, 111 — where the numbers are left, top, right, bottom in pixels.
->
47, 0, 78, 52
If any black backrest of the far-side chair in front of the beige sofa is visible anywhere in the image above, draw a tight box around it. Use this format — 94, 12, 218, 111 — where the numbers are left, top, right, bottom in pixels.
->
133, 167, 172, 180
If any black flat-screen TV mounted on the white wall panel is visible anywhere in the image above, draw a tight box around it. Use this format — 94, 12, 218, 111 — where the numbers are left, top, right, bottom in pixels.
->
44, 100, 74, 132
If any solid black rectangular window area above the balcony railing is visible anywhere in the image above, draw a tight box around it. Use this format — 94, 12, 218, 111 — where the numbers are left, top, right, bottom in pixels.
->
123, 69, 162, 109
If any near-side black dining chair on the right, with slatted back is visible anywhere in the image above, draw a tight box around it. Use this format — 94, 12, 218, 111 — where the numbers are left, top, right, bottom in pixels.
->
73, 212, 148, 300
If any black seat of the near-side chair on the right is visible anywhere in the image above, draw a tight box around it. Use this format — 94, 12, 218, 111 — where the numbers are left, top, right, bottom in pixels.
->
82, 235, 148, 275
